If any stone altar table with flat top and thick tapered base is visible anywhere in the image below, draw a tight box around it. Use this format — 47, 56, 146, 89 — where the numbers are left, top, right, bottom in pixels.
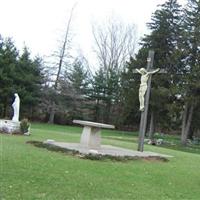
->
73, 120, 115, 149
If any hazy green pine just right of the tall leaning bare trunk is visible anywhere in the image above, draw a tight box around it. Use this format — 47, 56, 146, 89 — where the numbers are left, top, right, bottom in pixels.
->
61, 57, 91, 119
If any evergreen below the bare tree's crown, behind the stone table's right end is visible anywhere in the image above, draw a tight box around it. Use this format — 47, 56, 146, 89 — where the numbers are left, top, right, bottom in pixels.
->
91, 68, 120, 124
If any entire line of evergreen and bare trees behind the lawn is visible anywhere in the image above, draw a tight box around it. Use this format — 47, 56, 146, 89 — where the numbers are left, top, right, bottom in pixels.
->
0, 0, 200, 144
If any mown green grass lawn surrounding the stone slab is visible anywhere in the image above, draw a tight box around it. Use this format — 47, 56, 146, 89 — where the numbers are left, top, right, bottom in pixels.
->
0, 124, 200, 200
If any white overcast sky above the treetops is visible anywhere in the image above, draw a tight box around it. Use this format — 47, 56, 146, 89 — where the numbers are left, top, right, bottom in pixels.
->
0, 0, 185, 63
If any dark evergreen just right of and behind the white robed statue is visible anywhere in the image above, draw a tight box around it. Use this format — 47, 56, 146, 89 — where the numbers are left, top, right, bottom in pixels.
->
14, 47, 43, 118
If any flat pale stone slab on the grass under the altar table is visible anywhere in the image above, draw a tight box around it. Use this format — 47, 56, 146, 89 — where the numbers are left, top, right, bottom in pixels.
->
44, 140, 173, 158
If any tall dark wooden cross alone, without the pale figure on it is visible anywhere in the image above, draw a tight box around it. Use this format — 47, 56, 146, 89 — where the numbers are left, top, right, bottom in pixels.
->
134, 50, 165, 152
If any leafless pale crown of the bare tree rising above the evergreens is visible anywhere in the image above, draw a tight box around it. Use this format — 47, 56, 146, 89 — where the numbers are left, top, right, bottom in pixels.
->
92, 17, 136, 71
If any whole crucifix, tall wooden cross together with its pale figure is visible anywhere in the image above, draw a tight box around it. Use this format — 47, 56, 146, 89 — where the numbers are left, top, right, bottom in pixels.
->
136, 50, 166, 152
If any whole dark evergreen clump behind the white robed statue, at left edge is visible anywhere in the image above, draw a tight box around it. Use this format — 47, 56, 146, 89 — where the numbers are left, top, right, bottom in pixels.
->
0, 37, 42, 118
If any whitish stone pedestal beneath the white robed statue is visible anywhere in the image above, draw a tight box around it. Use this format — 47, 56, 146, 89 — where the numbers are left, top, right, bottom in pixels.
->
0, 119, 21, 134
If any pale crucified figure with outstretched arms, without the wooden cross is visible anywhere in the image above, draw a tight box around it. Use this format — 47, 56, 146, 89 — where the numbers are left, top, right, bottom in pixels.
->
136, 68, 160, 111
